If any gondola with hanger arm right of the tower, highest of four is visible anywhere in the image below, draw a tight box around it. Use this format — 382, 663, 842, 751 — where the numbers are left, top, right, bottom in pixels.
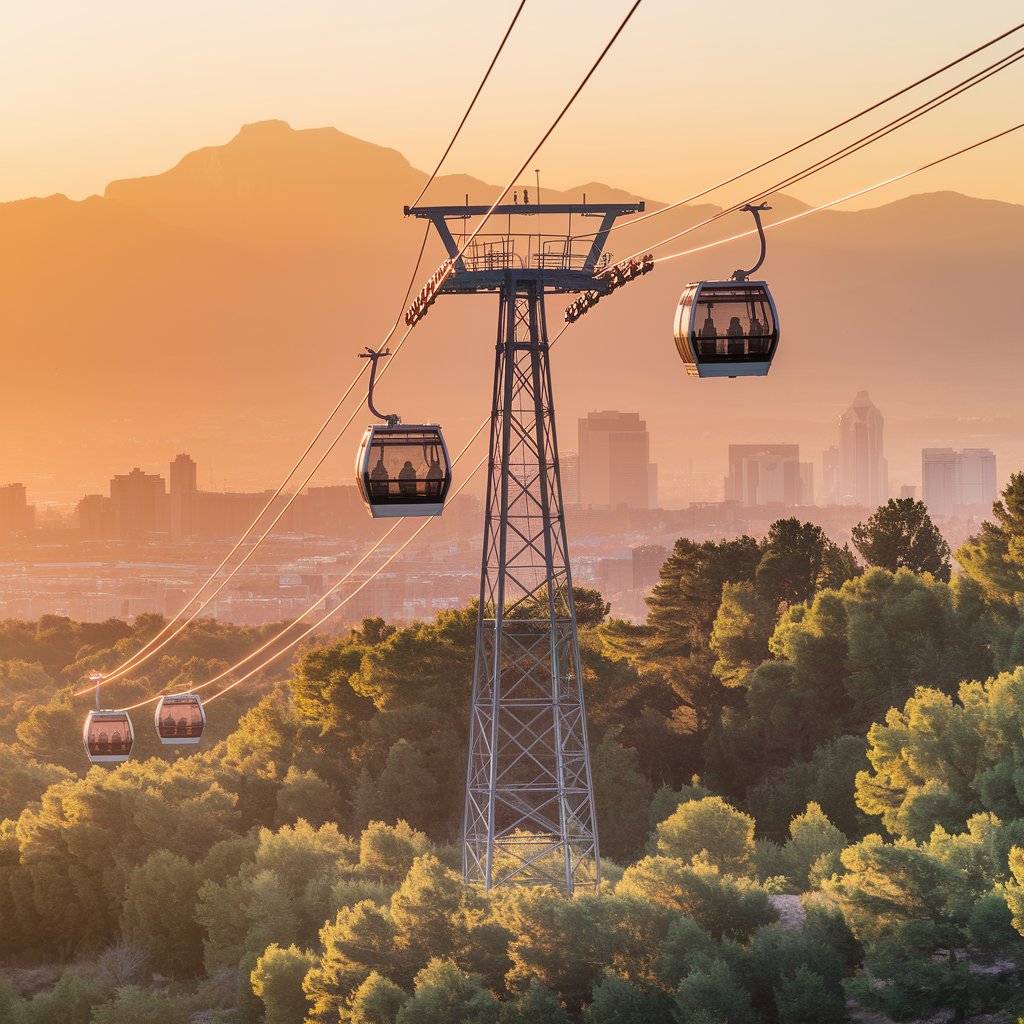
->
675, 203, 778, 377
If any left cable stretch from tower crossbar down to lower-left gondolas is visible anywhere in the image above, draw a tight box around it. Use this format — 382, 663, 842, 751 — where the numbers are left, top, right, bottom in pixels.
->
75, 225, 430, 696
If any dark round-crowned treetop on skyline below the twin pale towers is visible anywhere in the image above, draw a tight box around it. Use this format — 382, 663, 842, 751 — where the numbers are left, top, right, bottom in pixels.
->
853, 498, 949, 583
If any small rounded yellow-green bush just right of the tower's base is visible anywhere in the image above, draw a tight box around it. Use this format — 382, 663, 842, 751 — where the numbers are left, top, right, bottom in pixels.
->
657, 797, 754, 874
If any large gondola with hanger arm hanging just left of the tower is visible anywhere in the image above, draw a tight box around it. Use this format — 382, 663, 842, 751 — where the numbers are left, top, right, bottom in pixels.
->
355, 348, 452, 519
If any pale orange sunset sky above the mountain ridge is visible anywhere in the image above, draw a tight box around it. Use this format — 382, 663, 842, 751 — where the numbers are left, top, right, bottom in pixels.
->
0, 0, 1024, 206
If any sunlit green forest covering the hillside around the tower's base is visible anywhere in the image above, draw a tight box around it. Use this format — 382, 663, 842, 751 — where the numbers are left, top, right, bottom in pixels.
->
0, 481, 1024, 1024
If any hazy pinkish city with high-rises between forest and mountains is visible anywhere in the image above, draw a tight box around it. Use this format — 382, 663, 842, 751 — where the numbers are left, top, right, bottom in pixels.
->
0, 391, 998, 626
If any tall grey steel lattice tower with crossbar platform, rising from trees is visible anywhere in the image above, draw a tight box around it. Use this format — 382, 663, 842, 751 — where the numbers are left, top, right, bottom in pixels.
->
406, 195, 643, 893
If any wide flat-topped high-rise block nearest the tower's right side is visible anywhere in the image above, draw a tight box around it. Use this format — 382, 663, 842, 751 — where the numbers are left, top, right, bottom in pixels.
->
580, 412, 657, 509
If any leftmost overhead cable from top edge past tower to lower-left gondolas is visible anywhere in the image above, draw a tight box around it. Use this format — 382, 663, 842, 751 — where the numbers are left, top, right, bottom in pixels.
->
76, 0, 526, 696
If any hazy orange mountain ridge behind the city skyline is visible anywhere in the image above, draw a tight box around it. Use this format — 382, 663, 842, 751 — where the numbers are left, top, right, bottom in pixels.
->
0, 122, 1024, 501
